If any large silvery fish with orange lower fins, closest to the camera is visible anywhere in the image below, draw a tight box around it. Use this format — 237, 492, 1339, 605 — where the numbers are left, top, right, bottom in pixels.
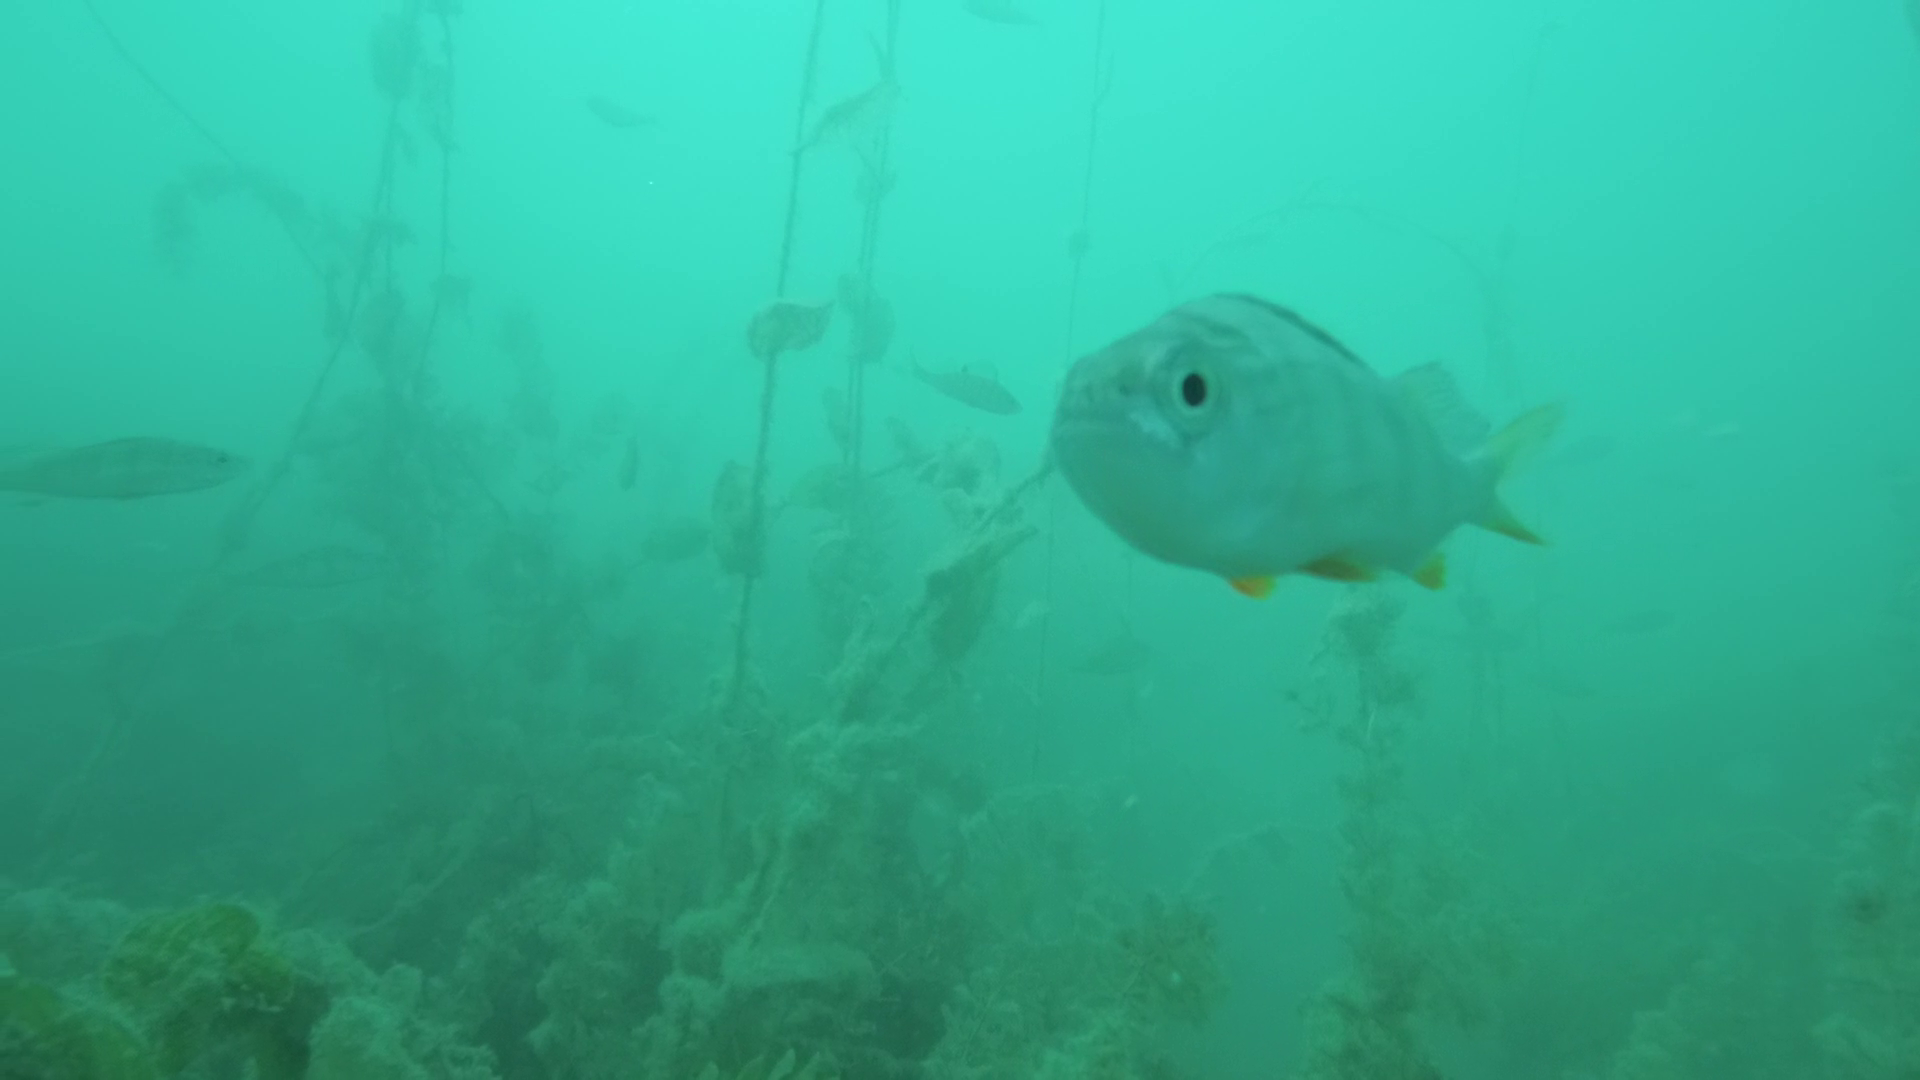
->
1050, 294, 1561, 596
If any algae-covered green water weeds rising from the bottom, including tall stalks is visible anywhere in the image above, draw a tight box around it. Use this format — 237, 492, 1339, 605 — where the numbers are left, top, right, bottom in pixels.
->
0, 0, 1920, 1080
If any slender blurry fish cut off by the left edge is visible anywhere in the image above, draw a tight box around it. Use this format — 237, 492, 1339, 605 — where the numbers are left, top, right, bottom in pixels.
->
0, 436, 248, 500
